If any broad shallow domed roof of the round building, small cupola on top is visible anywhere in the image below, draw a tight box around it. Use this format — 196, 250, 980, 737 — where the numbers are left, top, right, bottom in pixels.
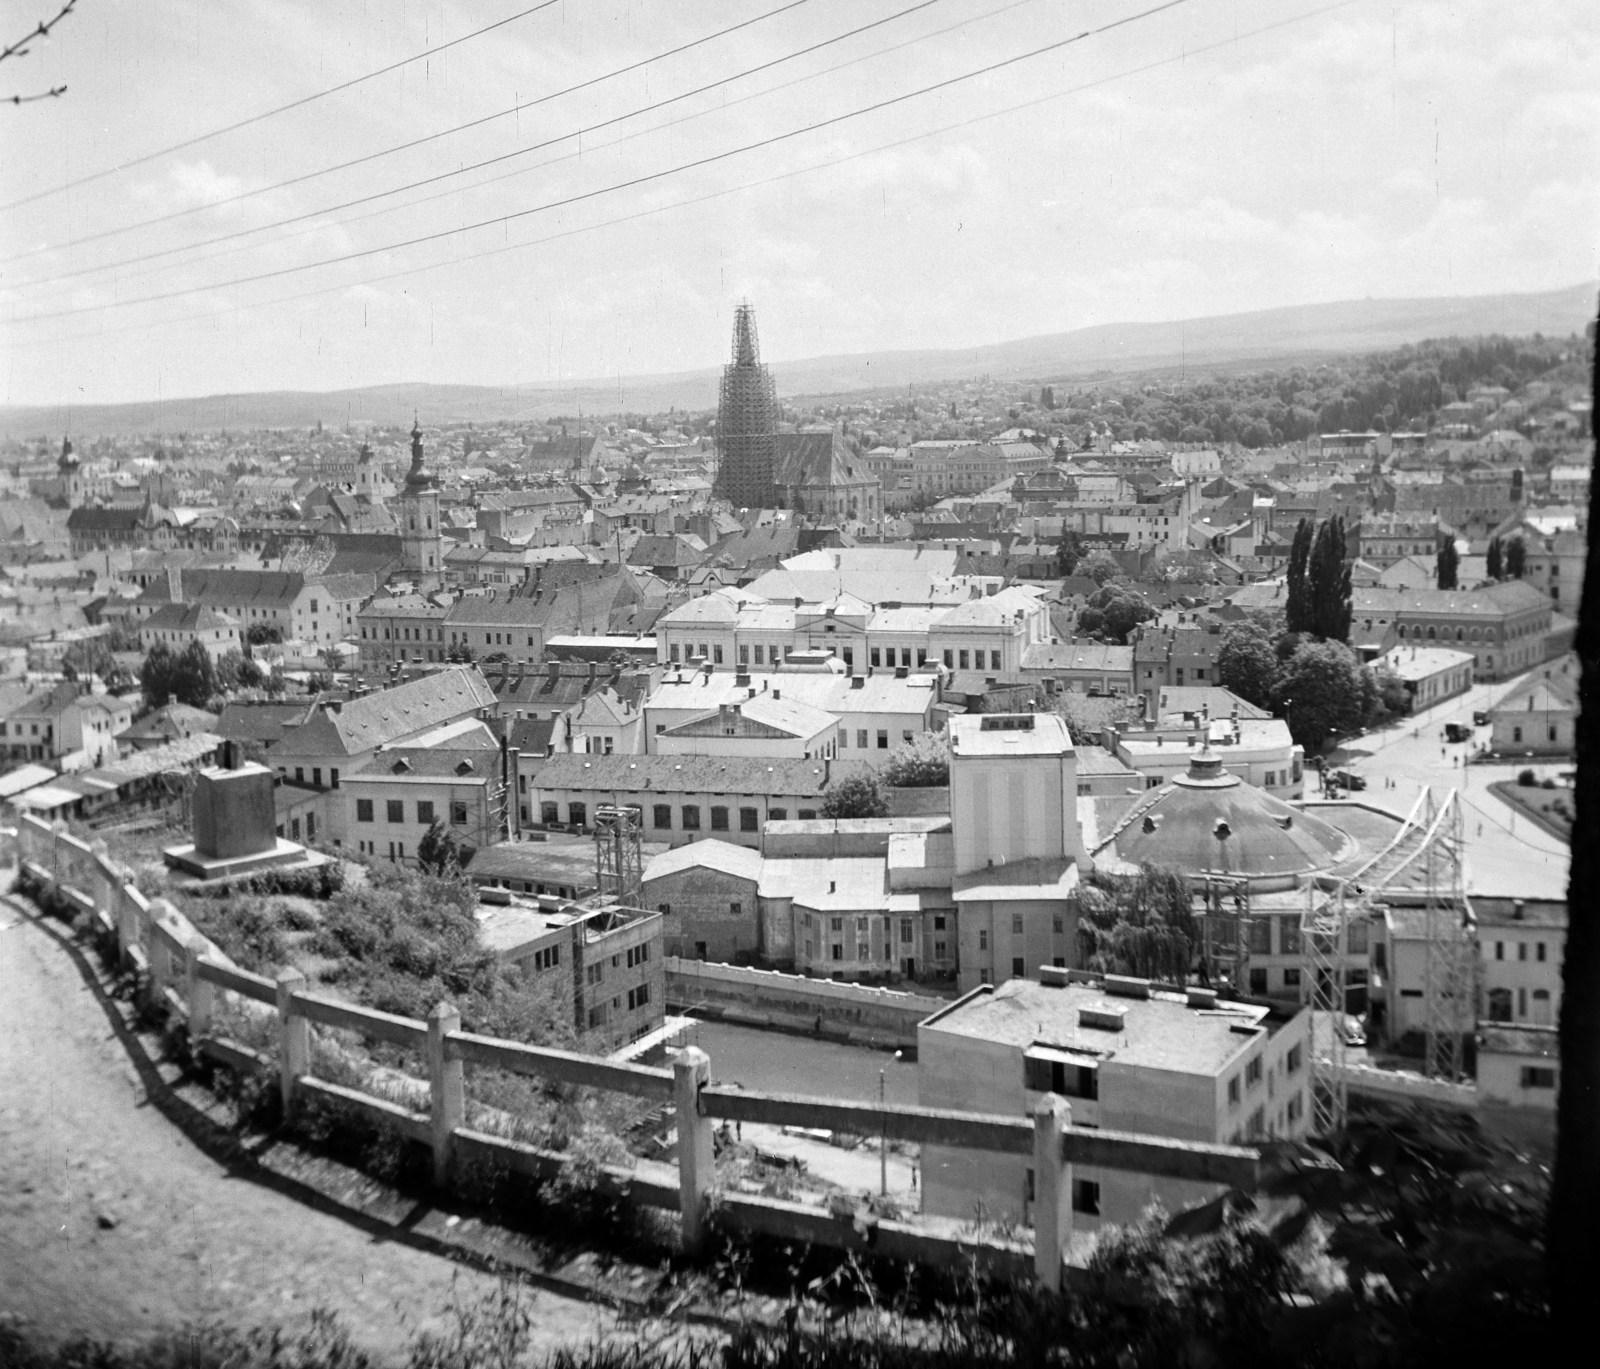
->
1094, 748, 1355, 881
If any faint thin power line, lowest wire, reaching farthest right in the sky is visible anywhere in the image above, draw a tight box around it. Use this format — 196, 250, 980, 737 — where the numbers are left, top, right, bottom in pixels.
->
18, 0, 1358, 345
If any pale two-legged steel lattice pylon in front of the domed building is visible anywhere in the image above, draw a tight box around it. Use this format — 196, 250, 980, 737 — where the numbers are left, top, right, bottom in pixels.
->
1301, 787, 1477, 1134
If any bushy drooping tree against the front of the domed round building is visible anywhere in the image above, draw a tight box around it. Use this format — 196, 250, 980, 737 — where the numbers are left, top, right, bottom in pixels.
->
1078, 865, 1198, 984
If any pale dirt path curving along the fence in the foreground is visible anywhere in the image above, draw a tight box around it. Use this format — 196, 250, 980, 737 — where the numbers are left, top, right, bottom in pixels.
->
0, 900, 611, 1356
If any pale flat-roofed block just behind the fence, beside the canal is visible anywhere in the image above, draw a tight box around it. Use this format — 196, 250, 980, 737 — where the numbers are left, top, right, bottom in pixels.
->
917, 968, 1310, 1230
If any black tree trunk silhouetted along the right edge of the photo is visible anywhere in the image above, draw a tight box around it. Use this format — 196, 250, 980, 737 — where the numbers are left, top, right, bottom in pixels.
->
1546, 297, 1600, 1324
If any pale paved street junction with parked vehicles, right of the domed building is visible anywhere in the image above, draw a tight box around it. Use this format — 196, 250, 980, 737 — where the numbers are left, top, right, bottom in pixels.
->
1318, 667, 1573, 899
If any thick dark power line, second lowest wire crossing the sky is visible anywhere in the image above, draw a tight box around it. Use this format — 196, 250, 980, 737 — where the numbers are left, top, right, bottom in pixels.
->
18, 0, 1189, 323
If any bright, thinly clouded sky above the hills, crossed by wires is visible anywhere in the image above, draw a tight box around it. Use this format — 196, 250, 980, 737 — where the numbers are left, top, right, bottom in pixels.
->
0, 0, 1600, 405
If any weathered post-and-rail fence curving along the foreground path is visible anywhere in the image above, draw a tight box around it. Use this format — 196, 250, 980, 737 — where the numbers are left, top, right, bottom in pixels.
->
16, 816, 1259, 1287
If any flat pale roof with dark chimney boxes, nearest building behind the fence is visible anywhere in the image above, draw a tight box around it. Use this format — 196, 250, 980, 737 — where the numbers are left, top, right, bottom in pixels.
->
918, 976, 1288, 1078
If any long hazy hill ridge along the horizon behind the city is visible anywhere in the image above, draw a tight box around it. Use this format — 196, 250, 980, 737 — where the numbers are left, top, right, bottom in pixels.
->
0, 283, 1595, 437
